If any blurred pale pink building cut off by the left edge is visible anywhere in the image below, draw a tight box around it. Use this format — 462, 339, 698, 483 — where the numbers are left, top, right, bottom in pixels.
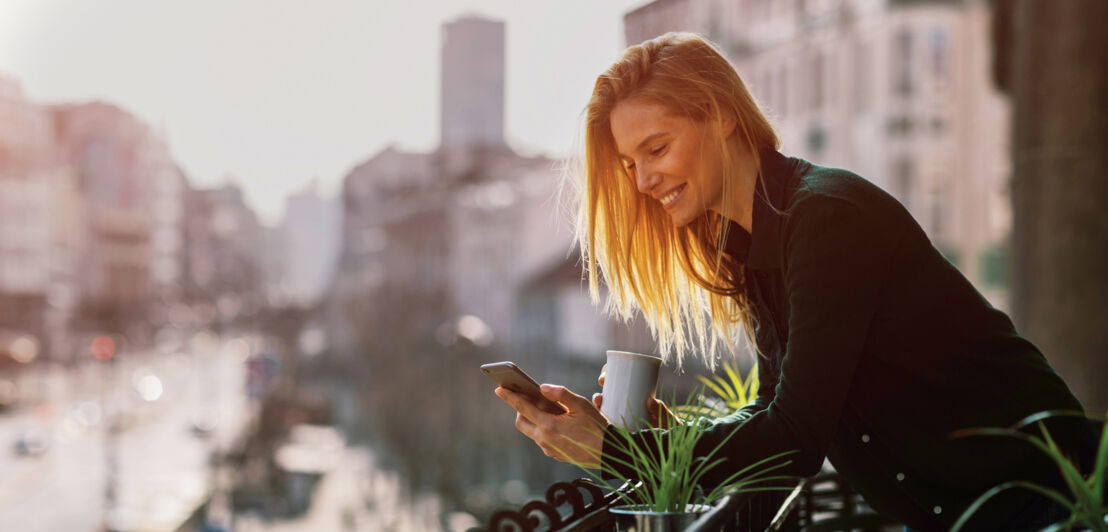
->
0, 76, 78, 361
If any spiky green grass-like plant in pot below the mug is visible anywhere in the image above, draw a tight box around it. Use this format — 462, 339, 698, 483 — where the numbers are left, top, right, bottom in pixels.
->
562, 392, 796, 512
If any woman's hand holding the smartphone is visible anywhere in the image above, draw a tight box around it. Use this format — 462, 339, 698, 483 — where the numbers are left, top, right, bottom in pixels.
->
494, 385, 608, 469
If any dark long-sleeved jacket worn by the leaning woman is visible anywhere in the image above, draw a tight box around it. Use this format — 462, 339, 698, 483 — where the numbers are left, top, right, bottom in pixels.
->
604, 151, 1087, 530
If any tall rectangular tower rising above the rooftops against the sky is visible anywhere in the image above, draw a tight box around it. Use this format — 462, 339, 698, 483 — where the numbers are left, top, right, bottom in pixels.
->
440, 17, 504, 147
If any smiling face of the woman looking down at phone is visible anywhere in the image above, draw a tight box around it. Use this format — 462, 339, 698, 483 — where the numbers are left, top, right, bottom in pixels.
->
609, 99, 724, 227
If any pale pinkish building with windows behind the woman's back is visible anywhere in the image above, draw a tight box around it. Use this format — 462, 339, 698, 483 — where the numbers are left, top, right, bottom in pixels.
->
624, 0, 1010, 307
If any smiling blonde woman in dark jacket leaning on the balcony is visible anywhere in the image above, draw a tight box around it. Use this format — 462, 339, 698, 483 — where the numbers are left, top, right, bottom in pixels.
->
496, 33, 1089, 530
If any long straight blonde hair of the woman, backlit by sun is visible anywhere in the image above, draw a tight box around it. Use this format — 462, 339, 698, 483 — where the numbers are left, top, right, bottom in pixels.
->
576, 32, 779, 367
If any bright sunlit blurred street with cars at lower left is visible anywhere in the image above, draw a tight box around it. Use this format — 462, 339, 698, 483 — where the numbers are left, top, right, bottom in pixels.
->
0, 336, 252, 531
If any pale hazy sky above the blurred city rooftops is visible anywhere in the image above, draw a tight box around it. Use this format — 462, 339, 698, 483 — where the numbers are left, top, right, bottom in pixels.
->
0, 0, 646, 224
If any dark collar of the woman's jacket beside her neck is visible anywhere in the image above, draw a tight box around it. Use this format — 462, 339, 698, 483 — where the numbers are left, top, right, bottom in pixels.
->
725, 150, 799, 270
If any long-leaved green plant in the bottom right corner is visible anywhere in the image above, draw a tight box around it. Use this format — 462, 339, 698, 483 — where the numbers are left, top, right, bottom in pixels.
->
951, 410, 1108, 532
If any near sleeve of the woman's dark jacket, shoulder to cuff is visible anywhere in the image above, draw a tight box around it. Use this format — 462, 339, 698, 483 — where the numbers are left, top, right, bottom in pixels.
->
604, 196, 901, 485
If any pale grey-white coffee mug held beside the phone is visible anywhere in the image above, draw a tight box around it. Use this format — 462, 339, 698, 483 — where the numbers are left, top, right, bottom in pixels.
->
601, 350, 661, 430
